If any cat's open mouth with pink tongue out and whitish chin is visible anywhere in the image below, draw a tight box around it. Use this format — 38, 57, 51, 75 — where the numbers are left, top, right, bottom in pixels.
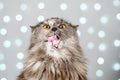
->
47, 34, 61, 48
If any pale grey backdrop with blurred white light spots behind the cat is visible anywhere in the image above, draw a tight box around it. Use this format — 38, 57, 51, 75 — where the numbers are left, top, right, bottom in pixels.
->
0, 0, 120, 80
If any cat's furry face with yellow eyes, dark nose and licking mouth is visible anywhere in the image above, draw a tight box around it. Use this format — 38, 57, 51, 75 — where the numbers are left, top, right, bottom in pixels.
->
32, 18, 76, 48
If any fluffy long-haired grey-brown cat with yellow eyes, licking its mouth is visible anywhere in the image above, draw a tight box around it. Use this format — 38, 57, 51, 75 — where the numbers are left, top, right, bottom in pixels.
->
17, 17, 87, 80
